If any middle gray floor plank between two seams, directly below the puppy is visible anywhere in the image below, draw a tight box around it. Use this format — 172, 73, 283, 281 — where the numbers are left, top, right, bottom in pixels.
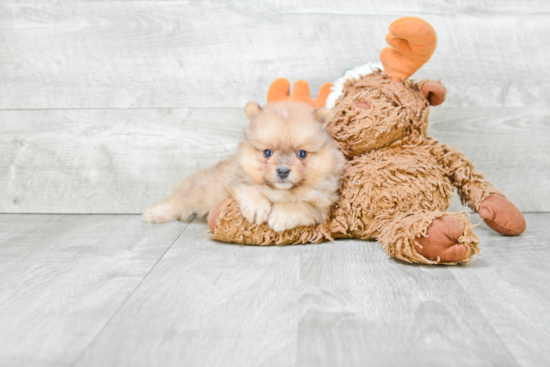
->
75, 223, 301, 366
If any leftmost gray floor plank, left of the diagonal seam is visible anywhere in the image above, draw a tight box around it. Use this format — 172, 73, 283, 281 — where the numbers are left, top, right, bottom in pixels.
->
0, 215, 186, 366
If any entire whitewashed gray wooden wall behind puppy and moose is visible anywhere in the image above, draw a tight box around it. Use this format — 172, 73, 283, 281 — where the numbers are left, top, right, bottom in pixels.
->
0, 0, 550, 213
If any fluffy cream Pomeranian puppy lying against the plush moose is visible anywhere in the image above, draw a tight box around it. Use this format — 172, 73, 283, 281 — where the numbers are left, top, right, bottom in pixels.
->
143, 102, 345, 232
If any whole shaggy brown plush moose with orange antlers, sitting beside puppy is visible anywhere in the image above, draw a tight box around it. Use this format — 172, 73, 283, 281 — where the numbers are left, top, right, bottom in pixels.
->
209, 17, 525, 265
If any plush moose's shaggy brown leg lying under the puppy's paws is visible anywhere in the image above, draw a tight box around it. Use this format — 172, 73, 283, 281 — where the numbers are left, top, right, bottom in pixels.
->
208, 199, 335, 245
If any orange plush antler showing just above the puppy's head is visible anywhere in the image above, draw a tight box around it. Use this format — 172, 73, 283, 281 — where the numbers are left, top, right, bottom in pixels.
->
267, 78, 333, 108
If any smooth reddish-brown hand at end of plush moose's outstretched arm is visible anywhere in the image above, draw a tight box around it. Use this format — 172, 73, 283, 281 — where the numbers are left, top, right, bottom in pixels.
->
479, 195, 527, 236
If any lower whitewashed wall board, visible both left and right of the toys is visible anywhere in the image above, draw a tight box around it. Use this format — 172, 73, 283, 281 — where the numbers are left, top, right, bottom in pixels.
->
0, 107, 550, 213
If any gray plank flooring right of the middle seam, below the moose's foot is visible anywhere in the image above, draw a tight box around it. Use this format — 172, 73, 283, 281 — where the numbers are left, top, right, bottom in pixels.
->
298, 213, 550, 366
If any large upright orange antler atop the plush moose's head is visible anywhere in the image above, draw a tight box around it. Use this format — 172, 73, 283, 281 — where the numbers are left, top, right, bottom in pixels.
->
380, 17, 437, 80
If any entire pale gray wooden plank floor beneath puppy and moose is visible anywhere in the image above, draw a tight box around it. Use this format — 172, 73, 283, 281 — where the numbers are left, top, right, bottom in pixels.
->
0, 213, 550, 366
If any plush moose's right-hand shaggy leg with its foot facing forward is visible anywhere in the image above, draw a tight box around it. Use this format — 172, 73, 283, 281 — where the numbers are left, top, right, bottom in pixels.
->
378, 212, 479, 265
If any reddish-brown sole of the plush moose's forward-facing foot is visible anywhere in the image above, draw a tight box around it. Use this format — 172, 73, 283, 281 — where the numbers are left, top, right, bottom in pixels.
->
415, 215, 468, 262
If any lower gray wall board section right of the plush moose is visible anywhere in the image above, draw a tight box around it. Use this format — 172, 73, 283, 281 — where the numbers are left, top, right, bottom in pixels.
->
428, 107, 550, 212
